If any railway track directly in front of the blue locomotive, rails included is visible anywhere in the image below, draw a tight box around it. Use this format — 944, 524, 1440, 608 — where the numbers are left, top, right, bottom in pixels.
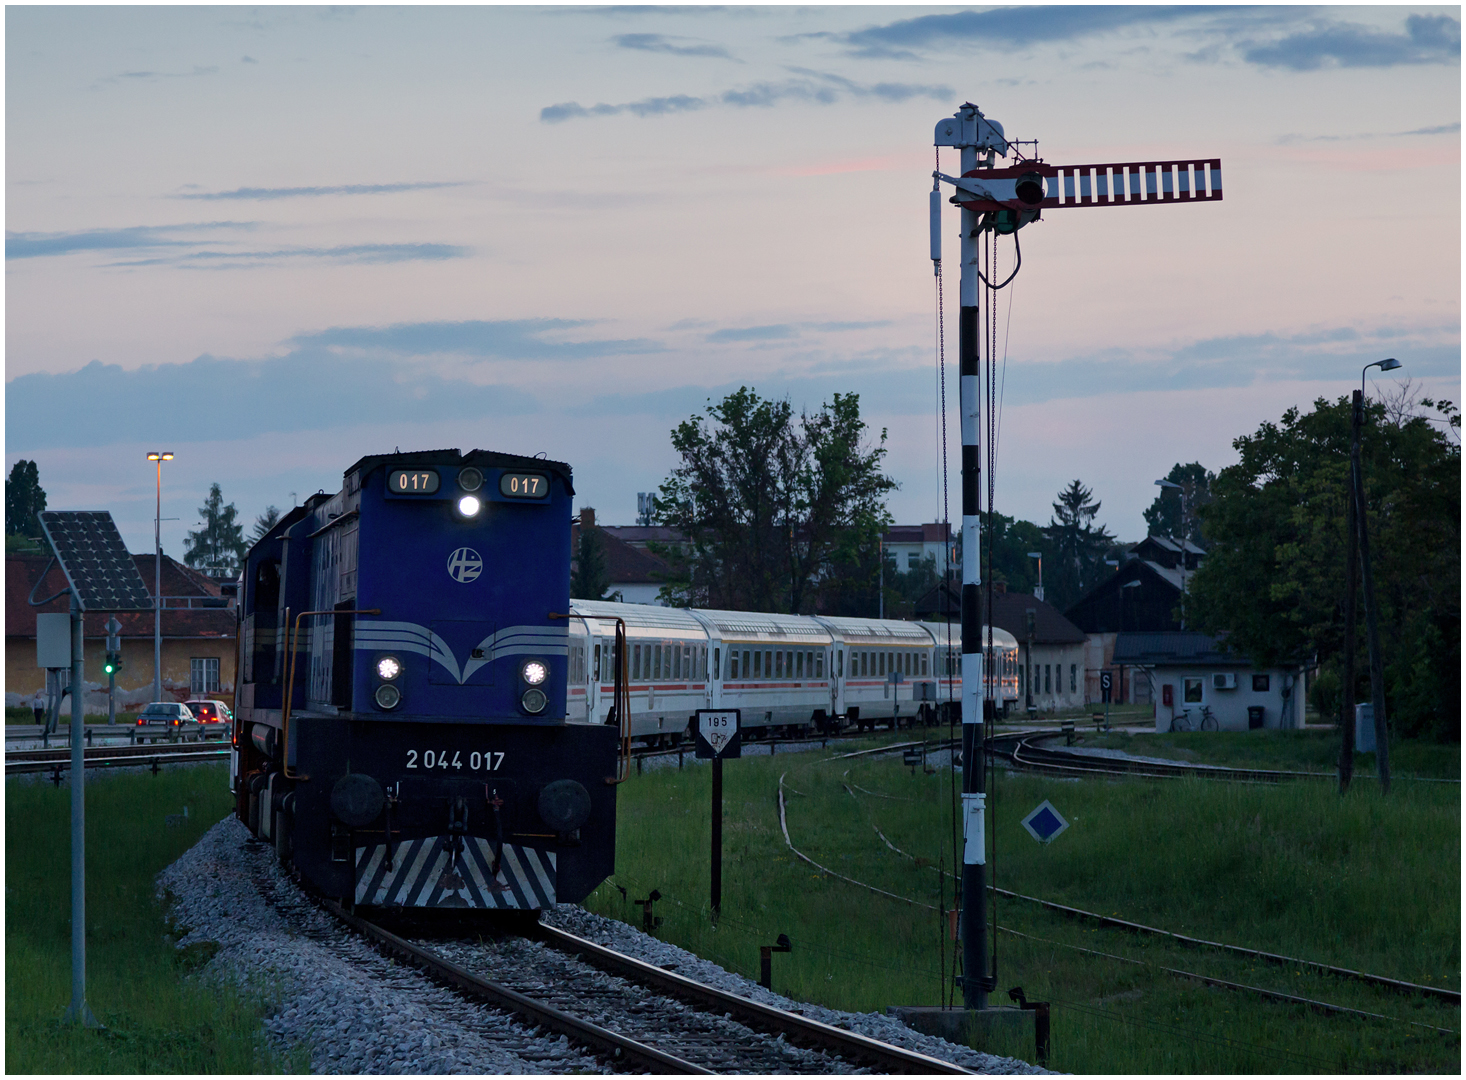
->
324, 901, 968, 1074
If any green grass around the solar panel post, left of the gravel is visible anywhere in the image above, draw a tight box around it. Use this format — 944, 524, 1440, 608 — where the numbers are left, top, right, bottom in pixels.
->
6, 765, 302, 1073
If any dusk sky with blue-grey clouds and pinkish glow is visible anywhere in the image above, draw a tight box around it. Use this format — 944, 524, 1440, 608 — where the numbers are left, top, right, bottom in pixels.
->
4, 6, 1462, 565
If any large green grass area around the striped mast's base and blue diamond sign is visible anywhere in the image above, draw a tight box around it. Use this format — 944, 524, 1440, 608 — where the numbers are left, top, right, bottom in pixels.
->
586, 733, 1460, 1073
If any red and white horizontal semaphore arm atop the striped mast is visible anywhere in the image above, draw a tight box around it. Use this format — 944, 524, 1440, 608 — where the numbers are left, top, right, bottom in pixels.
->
954, 158, 1221, 212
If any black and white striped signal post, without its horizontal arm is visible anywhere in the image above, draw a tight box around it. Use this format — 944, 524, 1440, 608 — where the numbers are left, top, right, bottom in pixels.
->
931, 104, 1007, 1008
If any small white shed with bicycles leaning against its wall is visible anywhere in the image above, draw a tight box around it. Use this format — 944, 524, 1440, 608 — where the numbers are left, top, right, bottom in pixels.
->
1114, 630, 1303, 731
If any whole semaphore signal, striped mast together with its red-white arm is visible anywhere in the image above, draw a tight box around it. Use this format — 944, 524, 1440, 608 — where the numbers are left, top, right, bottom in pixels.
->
931, 103, 1221, 1008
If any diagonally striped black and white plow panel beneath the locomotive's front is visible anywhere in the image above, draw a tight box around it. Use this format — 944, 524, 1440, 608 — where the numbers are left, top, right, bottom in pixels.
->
356, 837, 556, 910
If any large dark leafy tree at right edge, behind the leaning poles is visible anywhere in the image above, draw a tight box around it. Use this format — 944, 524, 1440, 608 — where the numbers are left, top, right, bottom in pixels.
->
1189, 397, 1460, 740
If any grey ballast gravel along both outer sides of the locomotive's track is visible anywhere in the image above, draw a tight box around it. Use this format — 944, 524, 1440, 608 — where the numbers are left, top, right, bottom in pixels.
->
158, 816, 1047, 1074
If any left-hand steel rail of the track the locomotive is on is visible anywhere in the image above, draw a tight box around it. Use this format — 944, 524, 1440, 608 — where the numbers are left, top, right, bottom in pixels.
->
323, 900, 712, 1076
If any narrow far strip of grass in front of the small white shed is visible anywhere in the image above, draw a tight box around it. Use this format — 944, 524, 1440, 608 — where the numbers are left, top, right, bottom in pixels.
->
1079, 730, 1462, 783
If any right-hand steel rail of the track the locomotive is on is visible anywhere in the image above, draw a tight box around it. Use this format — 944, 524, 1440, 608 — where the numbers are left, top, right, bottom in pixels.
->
532, 923, 969, 1076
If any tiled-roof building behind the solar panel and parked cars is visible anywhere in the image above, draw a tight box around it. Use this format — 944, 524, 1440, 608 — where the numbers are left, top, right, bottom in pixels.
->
4, 554, 235, 714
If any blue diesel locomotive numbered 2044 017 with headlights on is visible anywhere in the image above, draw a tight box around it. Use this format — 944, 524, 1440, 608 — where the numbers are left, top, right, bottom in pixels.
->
232, 450, 626, 910
